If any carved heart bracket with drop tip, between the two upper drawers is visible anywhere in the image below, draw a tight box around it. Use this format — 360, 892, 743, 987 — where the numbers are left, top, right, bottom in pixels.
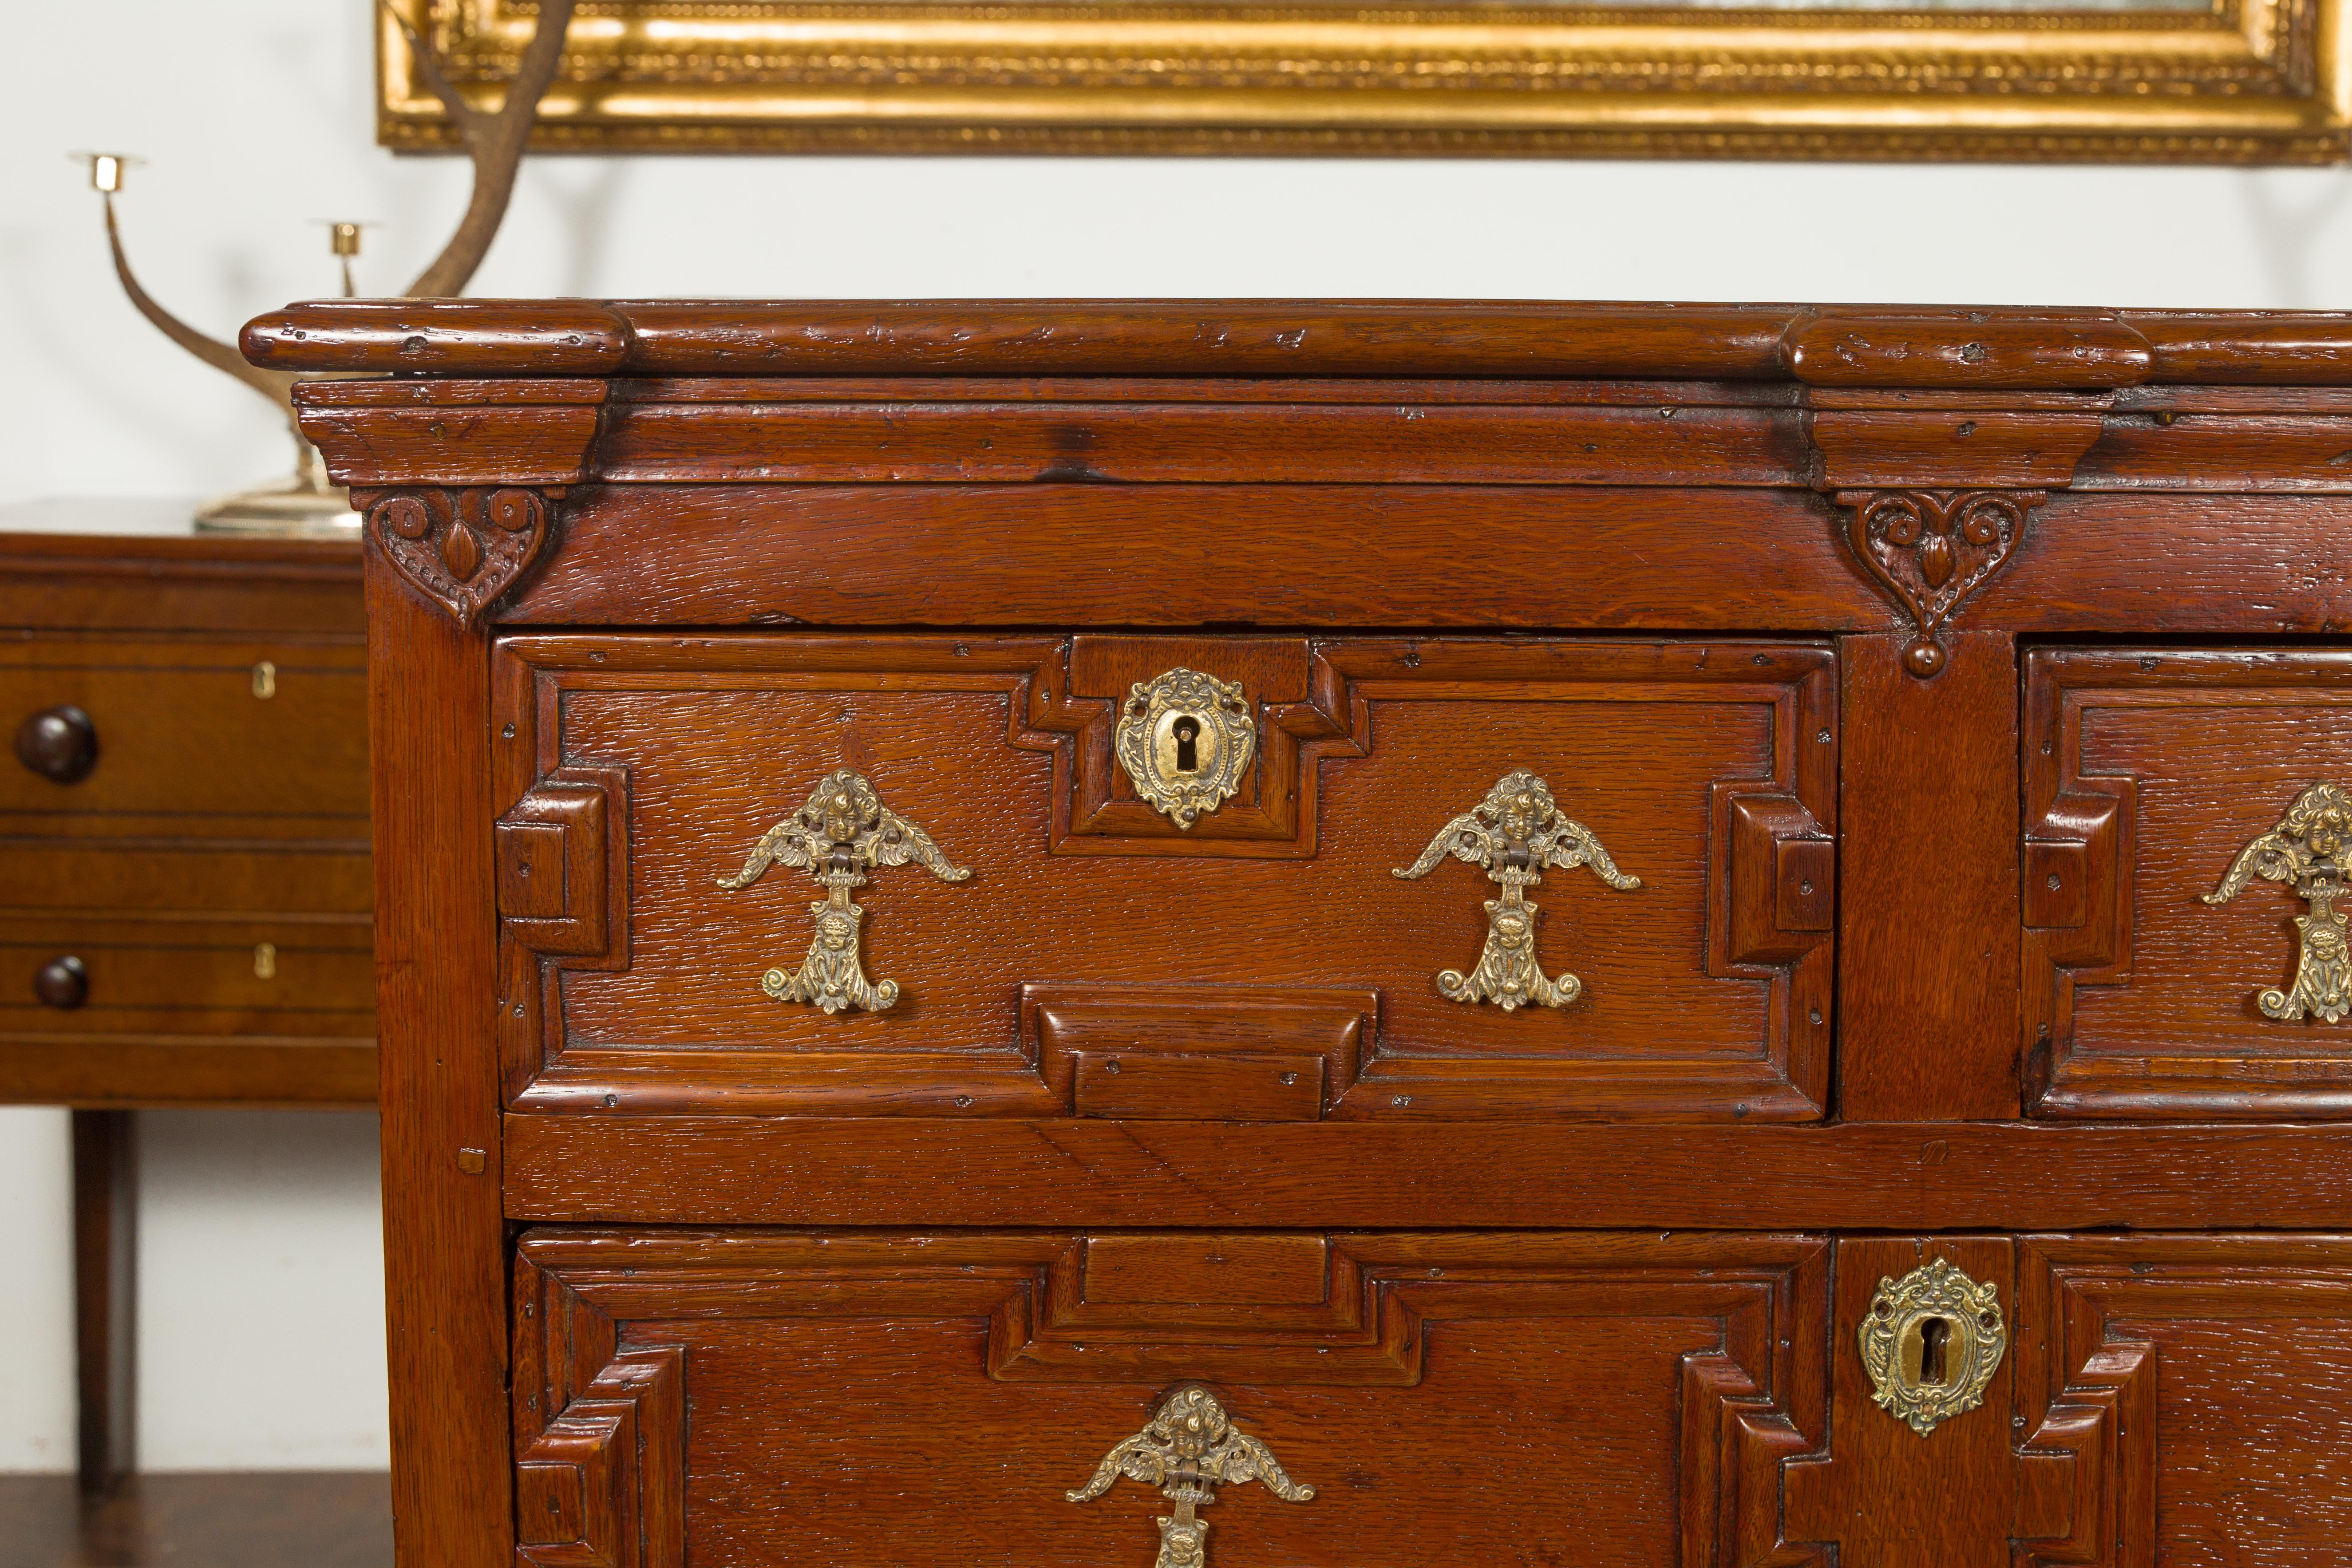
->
1834, 489, 2048, 679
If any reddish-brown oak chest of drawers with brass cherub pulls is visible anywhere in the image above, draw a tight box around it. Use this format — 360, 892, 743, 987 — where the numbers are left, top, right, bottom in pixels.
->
245, 301, 2352, 1568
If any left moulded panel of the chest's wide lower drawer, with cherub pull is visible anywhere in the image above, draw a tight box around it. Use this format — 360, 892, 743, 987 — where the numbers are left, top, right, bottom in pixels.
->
513, 1232, 1827, 1568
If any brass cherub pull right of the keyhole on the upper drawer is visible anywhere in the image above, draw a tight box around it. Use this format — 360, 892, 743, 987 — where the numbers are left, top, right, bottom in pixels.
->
1395, 769, 1642, 1013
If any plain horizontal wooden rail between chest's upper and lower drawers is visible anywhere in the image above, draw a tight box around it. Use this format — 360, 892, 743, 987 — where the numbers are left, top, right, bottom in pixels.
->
506, 1114, 2352, 1229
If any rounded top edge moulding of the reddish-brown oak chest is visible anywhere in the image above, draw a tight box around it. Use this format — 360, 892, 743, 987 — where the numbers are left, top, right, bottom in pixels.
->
240, 299, 2352, 388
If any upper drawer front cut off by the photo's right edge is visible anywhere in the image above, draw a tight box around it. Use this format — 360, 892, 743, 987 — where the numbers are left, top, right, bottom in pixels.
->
2020, 649, 2352, 1119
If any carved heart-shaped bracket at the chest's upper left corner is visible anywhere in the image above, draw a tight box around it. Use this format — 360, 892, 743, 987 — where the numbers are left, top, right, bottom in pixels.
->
353, 484, 565, 630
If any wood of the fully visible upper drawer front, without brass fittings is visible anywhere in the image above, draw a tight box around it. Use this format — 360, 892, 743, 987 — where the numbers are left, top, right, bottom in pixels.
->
491, 637, 1837, 1119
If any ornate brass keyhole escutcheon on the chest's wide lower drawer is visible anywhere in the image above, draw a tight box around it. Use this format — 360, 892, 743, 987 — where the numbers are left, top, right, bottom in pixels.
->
1861, 1258, 2008, 1436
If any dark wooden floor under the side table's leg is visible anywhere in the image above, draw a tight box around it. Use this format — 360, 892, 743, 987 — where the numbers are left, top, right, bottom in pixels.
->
0, 1472, 393, 1568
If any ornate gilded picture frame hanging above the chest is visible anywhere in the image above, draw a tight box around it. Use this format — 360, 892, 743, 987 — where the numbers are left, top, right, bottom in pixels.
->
376, 0, 2352, 165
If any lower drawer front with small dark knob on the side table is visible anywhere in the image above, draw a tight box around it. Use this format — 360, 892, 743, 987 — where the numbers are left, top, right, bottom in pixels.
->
0, 917, 376, 1039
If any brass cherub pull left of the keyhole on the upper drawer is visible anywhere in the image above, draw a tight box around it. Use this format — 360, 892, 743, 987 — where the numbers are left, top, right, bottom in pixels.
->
719, 769, 971, 1013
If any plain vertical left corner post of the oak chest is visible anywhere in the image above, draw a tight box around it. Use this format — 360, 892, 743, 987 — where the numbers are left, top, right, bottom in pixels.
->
367, 571, 513, 1568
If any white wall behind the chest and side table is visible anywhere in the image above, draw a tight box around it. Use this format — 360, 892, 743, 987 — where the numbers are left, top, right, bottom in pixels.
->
0, 0, 2352, 1469
